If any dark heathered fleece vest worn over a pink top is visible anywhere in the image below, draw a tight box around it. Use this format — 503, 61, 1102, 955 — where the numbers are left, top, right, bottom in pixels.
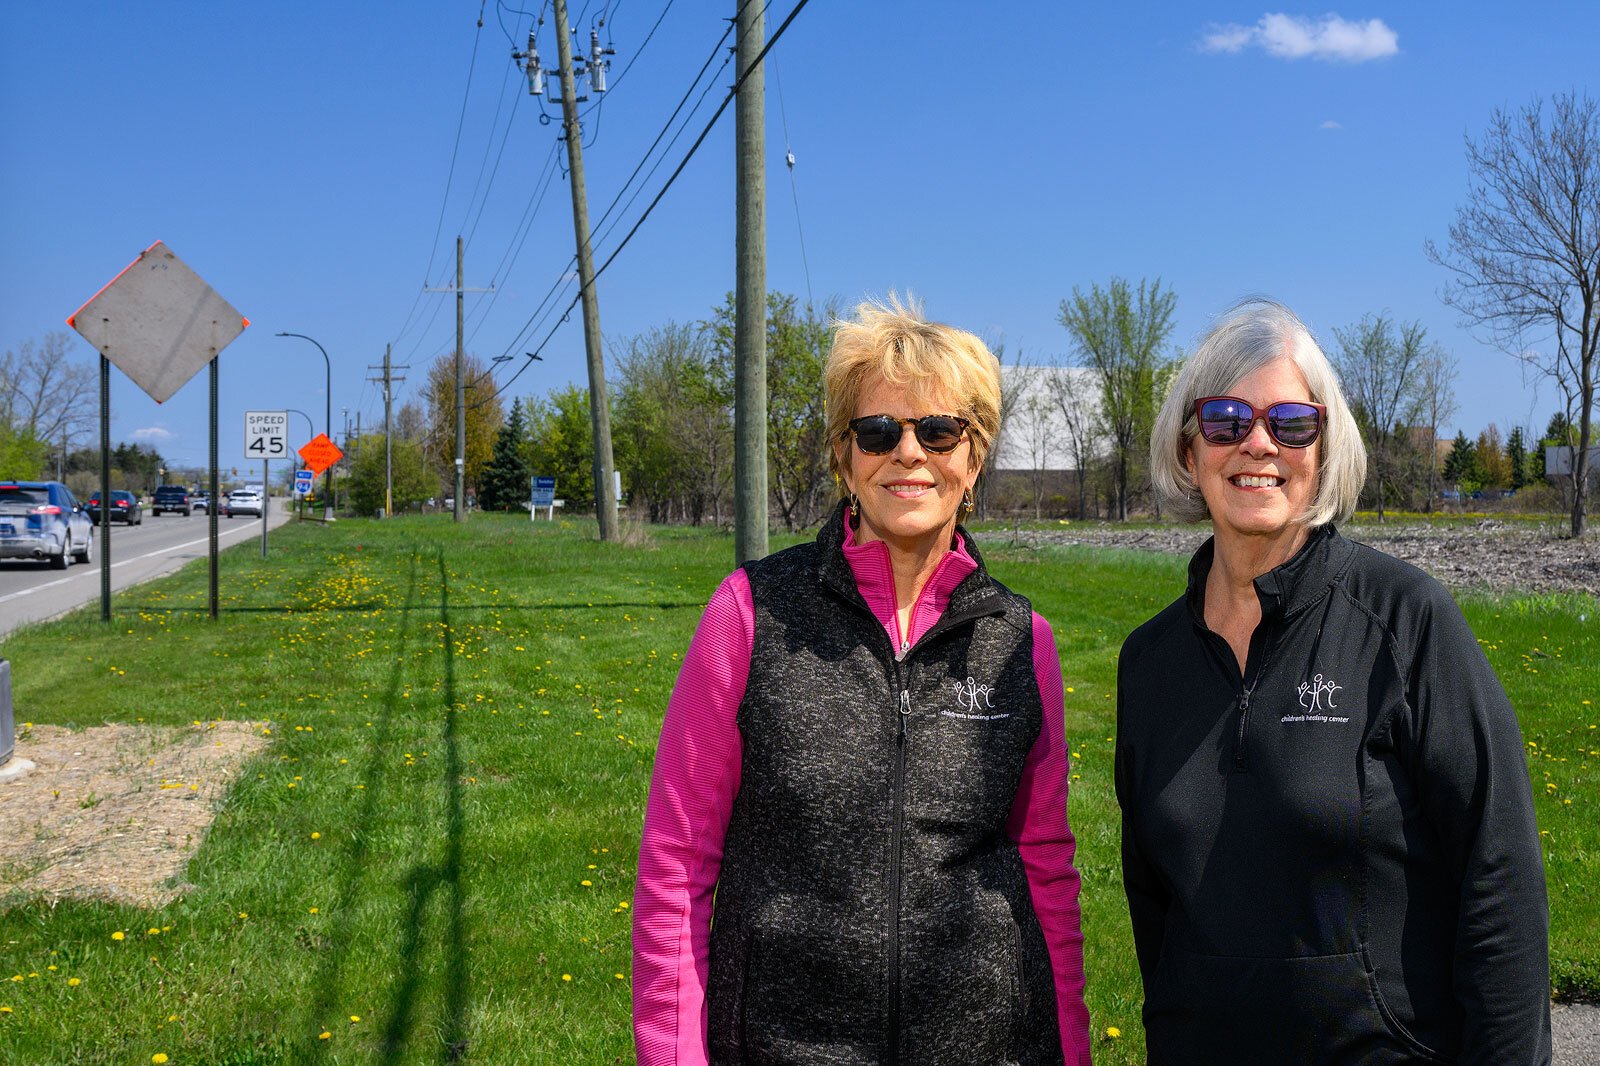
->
709, 509, 1061, 1064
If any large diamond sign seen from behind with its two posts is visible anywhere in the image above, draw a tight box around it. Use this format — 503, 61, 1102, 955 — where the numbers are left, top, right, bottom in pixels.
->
67, 240, 250, 621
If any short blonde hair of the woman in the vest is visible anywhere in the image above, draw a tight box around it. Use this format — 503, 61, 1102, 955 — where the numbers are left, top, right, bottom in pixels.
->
822, 293, 1000, 495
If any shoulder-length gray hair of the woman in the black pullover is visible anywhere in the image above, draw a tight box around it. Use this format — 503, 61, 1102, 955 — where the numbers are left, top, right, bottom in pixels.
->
1150, 296, 1366, 528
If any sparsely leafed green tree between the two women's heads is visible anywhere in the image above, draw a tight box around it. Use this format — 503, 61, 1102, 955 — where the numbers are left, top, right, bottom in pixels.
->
1058, 277, 1178, 520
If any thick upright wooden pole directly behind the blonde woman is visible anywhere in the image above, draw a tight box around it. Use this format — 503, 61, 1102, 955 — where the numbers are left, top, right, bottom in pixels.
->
733, 0, 766, 565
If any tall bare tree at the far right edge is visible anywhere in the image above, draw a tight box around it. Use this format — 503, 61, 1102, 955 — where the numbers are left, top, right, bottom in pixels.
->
1427, 93, 1600, 536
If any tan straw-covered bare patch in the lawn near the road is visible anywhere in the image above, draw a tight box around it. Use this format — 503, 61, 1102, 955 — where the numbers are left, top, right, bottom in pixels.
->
0, 722, 267, 908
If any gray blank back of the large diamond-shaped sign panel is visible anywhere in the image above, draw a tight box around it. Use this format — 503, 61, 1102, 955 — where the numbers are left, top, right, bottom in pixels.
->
67, 240, 250, 403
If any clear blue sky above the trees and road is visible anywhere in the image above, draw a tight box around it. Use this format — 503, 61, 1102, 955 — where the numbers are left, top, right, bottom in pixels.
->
0, 0, 1600, 466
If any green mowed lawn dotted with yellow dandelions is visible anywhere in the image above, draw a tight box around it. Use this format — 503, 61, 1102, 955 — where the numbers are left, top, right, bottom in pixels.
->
0, 515, 1600, 1066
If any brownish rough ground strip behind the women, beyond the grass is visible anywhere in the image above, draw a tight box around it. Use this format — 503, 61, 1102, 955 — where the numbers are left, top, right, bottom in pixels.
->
989, 519, 1600, 595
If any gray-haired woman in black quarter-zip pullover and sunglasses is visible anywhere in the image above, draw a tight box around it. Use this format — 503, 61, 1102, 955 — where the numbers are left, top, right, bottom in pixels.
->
1117, 299, 1550, 1066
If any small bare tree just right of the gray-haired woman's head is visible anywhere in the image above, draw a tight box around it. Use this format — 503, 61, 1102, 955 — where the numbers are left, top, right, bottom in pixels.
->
1333, 315, 1427, 522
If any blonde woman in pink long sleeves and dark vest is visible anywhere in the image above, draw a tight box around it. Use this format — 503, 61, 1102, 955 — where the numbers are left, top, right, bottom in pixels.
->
634, 294, 1090, 1066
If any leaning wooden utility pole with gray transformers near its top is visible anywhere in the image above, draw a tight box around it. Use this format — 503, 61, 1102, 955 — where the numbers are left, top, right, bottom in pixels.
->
556, 0, 618, 541
